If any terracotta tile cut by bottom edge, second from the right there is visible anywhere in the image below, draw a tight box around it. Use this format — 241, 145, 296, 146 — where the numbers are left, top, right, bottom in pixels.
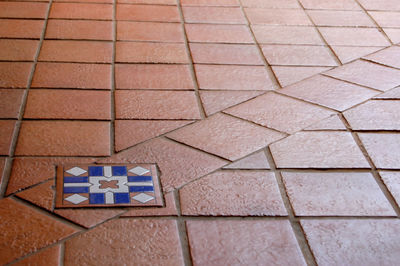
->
187, 220, 306, 265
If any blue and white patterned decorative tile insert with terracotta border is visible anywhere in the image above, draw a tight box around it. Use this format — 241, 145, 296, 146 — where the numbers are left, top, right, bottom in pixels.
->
56, 164, 163, 208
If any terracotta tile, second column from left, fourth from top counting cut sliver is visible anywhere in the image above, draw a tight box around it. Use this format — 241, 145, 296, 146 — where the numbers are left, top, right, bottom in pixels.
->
39, 40, 113, 63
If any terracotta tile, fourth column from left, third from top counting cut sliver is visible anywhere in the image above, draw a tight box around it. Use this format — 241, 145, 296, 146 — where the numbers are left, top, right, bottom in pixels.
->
185, 24, 254, 43
